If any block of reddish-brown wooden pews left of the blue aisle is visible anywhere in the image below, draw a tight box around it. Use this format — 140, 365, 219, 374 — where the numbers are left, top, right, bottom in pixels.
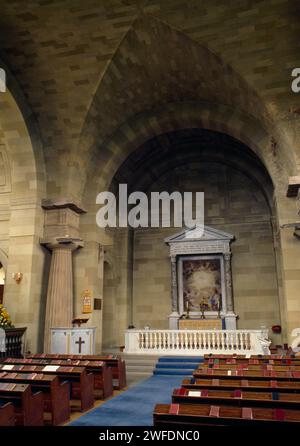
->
0, 354, 126, 426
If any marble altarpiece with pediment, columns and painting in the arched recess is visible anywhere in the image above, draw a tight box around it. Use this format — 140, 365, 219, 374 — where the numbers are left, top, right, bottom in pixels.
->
165, 226, 237, 330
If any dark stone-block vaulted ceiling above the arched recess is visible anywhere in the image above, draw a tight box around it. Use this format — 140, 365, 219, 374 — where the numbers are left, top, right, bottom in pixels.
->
0, 0, 300, 202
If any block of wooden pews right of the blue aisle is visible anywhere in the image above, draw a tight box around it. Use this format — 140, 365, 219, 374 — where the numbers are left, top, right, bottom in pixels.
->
153, 355, 300, 427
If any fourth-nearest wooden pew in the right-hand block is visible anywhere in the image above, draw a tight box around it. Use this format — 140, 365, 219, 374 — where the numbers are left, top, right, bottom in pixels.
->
193, 367, 300, 381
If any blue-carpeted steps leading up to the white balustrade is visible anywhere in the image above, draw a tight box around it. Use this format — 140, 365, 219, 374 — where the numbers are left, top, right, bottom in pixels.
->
153, 356, 204, 376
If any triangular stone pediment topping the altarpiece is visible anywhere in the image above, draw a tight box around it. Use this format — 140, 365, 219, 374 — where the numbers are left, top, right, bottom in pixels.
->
165, 226, 235, 244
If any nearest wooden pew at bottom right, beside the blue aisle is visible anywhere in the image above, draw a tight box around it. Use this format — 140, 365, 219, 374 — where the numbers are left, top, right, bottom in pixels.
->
153, 404, 300, 428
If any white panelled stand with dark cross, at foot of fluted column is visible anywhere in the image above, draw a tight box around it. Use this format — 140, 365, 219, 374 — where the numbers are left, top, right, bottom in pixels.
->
50, 327, 96, 355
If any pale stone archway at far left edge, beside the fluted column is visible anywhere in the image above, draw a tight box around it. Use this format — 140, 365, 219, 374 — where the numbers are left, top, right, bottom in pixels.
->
0, 71, 45, 351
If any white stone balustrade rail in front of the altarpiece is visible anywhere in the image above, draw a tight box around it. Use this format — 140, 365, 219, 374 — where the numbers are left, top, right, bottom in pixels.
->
124, 329, 270, 355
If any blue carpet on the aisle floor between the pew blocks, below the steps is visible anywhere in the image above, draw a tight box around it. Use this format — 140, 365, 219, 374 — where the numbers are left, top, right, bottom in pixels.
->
69, 373, 183, 426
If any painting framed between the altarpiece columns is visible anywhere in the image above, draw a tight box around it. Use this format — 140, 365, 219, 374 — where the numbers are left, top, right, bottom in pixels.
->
178, 255, 226, 316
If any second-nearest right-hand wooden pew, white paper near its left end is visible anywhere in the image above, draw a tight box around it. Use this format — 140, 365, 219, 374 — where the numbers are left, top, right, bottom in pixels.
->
172, 388, 300, 410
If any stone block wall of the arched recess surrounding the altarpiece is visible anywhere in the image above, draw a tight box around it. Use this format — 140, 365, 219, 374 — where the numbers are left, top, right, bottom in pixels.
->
133, 163, 281, 341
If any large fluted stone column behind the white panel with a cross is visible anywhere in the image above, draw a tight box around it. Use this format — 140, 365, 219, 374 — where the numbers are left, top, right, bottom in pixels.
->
44, 239, 80, 353
